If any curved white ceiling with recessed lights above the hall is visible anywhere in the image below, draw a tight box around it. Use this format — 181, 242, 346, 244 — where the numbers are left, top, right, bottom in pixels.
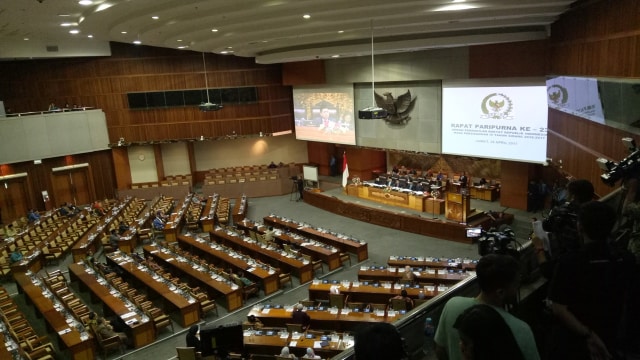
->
0, 0, 574, 63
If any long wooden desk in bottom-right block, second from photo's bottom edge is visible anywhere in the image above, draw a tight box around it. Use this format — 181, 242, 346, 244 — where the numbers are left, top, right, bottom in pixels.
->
247, 308, 401, 331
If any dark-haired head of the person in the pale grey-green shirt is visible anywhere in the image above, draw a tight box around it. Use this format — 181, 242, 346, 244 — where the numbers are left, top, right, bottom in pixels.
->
476, 254, 520, 305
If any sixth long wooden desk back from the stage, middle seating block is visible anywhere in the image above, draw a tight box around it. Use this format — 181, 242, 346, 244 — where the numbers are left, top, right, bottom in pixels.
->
105, 252, 200, 327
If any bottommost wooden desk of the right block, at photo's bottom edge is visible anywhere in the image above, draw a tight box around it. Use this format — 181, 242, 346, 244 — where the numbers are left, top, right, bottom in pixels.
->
243, 331, 353, 359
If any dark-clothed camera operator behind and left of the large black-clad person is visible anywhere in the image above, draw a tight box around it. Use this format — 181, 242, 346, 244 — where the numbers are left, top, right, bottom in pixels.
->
531, 179, 594, 279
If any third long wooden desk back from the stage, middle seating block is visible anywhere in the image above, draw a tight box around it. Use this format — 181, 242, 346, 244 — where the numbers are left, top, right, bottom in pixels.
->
209, 229, 313, 284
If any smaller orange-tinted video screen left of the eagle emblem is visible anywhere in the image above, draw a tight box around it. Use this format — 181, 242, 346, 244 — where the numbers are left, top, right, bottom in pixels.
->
293, 85, 356, 145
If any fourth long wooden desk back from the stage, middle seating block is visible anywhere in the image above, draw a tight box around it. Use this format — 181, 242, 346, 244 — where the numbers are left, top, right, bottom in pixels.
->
178, 235, 280, 295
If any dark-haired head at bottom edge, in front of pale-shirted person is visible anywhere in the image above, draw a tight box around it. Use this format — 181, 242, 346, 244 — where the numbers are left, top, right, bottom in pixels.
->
453, 304, 524, 360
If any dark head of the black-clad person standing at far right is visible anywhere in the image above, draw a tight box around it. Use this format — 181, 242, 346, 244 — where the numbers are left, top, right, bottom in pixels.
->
578, 201, 616, 243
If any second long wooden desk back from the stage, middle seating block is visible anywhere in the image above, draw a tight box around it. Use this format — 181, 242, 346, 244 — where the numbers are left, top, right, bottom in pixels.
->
235, 219, 342, 272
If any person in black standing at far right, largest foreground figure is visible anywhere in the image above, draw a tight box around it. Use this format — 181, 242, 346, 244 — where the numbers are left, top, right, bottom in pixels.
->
547, 201, 637, 360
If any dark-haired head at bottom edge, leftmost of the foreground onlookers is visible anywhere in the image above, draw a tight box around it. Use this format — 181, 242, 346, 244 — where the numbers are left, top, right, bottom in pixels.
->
354, 323, 407, 360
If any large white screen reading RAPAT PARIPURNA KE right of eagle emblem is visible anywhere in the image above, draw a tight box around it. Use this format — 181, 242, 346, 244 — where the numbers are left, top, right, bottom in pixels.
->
442, 80, 548, 163
